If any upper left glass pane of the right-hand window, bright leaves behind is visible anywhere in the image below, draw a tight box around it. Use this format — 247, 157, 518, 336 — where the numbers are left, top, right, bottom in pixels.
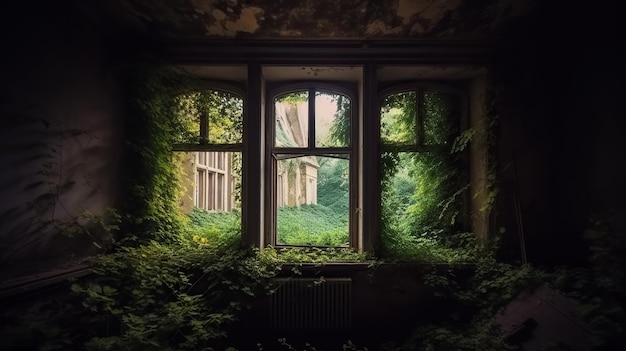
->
380, 91, 416, 145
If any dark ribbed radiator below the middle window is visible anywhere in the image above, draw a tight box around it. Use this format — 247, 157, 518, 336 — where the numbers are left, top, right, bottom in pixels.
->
270, 278, 352, 329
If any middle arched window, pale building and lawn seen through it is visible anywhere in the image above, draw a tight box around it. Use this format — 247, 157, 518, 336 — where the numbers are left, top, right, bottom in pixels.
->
267, 83, 357, 246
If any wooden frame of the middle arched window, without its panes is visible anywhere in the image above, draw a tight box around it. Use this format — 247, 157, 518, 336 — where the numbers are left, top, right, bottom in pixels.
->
262, 80, 361, 249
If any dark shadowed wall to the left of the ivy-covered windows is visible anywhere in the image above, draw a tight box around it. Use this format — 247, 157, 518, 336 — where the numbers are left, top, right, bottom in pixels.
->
0, 1, 123, 277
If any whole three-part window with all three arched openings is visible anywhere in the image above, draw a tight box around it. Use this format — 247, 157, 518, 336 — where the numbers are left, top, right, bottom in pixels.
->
177, 58, 486, 253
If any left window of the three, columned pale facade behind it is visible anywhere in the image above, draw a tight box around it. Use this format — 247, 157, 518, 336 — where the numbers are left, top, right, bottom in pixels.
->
174, 87, 243, 230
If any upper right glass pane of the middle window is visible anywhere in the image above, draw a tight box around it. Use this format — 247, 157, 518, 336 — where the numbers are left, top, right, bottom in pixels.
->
315, 92, 351, 147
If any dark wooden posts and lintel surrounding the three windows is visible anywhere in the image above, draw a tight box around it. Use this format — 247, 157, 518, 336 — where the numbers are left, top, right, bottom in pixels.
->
173, 62, 484, 255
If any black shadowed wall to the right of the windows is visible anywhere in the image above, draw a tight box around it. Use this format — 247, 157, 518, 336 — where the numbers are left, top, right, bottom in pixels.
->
496, 1, 626, 264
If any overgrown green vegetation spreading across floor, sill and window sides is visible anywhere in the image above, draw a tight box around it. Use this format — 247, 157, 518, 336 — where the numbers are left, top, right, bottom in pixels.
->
2, 64, 626, 351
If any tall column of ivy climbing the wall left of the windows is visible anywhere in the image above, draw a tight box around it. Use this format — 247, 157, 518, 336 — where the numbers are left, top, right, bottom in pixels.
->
121, 64, 189, 242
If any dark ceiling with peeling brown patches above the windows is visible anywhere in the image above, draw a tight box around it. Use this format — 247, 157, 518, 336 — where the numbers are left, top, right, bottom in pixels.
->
88, 0, 534, 40
